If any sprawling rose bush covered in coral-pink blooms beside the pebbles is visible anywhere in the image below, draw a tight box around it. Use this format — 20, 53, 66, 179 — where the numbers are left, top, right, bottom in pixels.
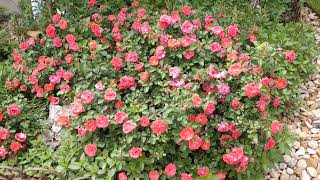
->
0, 0, 308, 180
